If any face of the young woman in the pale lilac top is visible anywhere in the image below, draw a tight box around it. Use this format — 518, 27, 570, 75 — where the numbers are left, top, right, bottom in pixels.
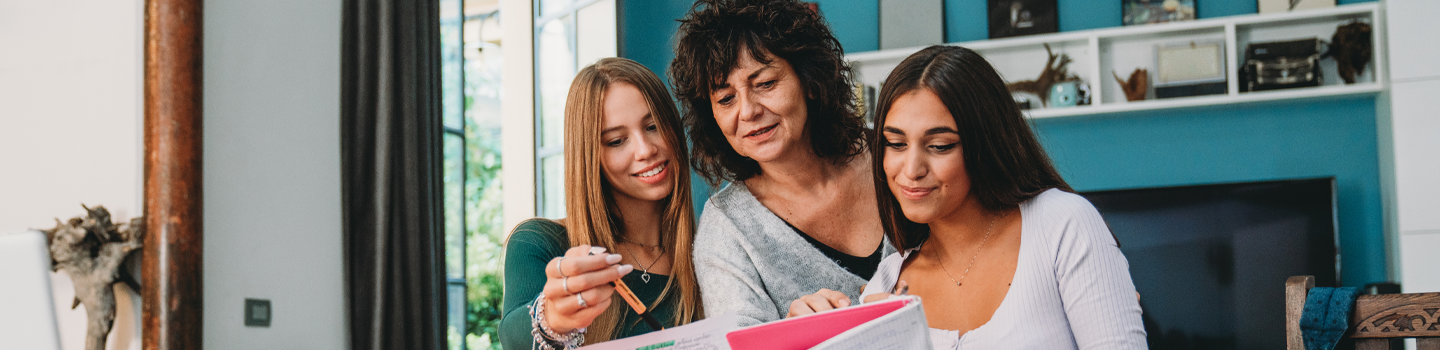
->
881, 88, 971, 223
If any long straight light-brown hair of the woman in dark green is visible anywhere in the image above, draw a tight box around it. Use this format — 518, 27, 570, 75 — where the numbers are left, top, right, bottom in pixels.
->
564, 58, 704, 343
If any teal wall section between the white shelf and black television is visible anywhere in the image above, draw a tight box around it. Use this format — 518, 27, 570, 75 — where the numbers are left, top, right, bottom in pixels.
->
1032, 97, 1387, 287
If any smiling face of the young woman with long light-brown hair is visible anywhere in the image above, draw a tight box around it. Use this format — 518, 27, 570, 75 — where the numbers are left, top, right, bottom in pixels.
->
600, 82, 675, 200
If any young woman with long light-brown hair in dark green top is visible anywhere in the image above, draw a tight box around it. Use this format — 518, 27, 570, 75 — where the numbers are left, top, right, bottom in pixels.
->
500, 58, 704, 349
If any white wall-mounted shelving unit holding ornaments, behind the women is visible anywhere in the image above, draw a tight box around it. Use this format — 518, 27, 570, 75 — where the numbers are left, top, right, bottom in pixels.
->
845, 3, 1388, 118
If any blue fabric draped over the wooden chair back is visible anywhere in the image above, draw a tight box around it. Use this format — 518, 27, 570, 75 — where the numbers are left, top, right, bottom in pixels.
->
1300, 287, 1359, 350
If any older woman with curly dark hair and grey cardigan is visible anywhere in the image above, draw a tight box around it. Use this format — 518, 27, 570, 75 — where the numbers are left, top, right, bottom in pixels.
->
670, 0, 893, 326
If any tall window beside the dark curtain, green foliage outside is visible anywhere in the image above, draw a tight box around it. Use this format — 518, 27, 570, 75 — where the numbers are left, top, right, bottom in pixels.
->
438, 0, 504, 350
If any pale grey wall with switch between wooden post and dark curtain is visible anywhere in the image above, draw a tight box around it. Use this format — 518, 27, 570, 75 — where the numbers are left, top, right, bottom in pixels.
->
204, 0, 348, 350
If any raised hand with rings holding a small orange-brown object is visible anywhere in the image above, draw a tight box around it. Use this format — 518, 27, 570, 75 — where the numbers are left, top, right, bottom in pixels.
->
541, 245, 635, 334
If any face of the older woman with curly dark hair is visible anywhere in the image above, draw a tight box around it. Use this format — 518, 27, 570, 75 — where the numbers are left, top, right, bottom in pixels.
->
710, 50, 809, 163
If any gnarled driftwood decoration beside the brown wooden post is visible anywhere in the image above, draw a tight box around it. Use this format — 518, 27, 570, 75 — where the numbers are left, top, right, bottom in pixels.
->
43, 205, 144, 350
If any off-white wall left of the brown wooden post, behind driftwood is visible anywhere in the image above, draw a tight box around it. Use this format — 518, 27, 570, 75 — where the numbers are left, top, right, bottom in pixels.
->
0, 0, 144, 350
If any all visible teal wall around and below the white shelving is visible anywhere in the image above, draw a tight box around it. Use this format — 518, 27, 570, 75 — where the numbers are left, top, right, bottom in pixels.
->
621, 0, 1388, 287
